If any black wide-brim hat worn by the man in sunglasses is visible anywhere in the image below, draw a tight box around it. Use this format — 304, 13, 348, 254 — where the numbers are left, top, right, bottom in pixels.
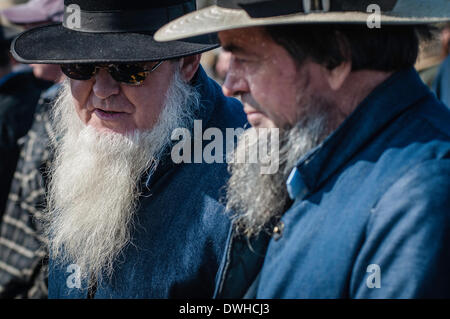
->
11, 0, 218, 64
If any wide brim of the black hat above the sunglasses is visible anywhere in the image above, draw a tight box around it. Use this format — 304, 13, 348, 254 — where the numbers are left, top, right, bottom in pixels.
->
11, 24, 218, 64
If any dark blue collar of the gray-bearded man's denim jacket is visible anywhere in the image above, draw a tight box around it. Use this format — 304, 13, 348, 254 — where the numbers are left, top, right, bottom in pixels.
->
297, 68, 430, 192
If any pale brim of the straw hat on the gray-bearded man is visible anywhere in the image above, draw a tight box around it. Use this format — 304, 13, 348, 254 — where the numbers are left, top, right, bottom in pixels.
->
155, 5, 449, 41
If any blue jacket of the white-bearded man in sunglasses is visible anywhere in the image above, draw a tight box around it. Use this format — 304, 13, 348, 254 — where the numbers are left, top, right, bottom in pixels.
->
49, 66, 246, 298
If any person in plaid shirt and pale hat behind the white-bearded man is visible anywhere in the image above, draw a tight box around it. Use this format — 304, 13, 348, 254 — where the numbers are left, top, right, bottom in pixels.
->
0, 0, 64, 298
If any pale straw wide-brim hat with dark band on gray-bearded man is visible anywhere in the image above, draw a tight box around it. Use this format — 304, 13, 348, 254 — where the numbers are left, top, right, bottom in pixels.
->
155, 0, 450, 41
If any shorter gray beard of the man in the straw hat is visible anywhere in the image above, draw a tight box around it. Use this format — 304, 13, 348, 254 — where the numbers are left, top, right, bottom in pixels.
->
226, 99, 335, 237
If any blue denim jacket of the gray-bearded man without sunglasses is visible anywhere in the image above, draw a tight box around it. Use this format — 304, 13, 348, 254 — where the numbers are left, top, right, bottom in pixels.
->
216, 68, 450, 298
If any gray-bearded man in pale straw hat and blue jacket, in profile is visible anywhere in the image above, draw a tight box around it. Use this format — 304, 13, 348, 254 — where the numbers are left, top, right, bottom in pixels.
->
155, 0, 450, 299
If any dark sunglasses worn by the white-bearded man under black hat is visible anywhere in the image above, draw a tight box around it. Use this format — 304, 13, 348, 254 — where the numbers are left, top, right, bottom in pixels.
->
61, 61, 164, 85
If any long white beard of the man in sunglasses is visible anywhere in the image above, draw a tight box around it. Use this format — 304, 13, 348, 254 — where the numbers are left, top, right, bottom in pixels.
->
44, 72, 199, 281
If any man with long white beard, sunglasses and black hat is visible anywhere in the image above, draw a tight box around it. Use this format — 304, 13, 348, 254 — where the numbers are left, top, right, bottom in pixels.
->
7, 0, 245, 298
